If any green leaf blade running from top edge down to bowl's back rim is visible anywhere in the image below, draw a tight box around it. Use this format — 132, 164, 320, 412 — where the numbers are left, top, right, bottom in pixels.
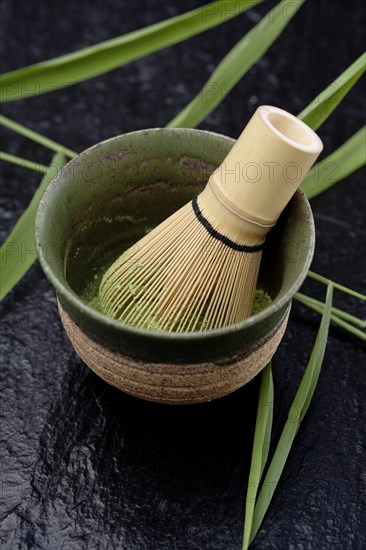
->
167, 0, 305, 128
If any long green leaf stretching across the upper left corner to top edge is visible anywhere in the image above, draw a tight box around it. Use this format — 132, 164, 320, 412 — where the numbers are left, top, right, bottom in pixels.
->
0, 0, 263, 101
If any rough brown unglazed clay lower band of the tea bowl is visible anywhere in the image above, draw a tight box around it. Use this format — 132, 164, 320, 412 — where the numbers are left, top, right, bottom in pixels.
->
58, 302, 291, 405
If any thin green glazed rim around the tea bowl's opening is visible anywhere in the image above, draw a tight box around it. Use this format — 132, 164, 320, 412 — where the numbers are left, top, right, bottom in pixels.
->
35, 127, 315, 342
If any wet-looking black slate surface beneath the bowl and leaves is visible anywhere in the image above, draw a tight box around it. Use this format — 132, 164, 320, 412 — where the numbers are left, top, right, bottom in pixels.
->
0, 0, 366, 550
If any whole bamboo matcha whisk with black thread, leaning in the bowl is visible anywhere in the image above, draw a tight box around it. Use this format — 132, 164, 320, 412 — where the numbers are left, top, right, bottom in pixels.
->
99, 106, 323, 332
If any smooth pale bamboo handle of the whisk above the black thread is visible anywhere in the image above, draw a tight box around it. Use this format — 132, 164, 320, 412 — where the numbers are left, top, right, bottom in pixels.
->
209, 105, 323, 229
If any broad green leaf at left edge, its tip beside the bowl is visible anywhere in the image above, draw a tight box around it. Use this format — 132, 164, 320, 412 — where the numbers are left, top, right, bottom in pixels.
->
0, 153, 65, 300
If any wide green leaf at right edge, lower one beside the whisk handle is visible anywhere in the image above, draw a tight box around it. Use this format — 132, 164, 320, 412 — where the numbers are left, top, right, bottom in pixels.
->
301, 126, 366, 199
